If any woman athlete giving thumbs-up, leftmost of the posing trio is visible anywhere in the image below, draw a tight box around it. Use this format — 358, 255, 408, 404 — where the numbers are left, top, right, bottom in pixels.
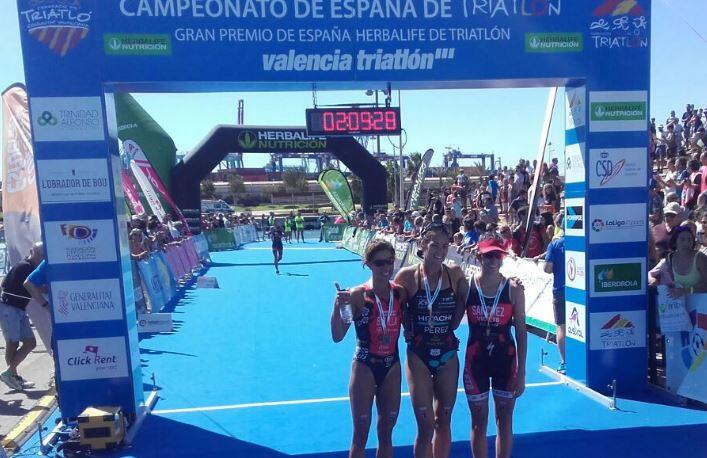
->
331, 240, 405, 458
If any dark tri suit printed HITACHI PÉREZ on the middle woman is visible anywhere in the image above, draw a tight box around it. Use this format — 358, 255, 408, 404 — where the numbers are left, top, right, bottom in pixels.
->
407, 264, 459, 377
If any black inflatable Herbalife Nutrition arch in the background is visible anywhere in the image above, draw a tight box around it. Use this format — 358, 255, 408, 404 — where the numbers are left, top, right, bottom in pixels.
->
171, 126, 388, 229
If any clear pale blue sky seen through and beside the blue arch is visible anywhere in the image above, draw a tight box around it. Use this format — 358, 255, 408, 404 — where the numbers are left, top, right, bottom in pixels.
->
0, 0, 707, 172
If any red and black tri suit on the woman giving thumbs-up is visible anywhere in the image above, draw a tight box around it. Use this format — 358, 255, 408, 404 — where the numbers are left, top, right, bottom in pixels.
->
354, 282, 403, 387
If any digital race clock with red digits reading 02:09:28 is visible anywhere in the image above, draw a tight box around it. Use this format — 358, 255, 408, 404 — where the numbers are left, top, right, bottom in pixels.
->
307, 107, 401, 136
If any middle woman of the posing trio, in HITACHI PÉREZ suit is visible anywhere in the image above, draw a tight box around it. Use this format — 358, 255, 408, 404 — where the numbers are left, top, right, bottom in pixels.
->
395, 223, 466, 458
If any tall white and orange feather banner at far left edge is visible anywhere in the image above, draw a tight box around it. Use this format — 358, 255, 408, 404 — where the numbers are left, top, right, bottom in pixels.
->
0, 85, 42, 268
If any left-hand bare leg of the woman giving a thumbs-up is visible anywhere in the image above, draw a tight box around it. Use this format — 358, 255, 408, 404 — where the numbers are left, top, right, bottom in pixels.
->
349, 361, 376, 458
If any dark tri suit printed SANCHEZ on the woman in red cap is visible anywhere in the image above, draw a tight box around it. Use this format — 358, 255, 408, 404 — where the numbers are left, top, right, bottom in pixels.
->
463, 277, 518, 402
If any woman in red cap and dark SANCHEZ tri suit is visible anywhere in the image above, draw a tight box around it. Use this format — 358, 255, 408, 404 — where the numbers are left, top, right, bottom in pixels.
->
463, 238, 528, 458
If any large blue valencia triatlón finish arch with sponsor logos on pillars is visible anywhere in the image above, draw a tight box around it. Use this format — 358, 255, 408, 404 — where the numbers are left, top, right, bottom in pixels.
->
17, 0, 651, 417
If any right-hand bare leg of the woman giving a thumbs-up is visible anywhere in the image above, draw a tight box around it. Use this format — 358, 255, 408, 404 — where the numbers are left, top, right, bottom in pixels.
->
376, 362, 402, 458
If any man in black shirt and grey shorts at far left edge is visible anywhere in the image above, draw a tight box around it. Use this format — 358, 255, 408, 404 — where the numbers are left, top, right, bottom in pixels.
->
0, 242, 44, 390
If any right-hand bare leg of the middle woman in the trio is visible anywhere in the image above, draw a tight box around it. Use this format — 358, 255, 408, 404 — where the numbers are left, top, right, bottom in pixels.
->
432, 354, 459, 458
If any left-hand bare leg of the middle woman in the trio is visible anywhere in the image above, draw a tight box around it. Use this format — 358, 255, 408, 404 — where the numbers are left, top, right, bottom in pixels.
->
405, 350, 435, 458
